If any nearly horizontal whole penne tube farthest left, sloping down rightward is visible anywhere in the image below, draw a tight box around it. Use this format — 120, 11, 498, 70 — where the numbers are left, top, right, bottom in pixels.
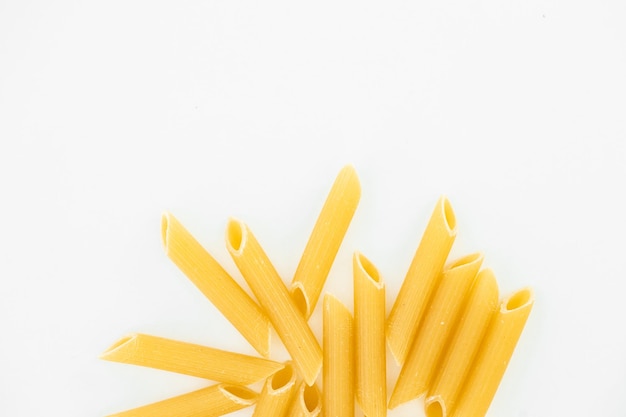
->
100, 333, 284, 385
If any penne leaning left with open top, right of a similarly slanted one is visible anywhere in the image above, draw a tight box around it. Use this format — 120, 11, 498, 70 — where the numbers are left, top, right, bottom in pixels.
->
226, 219, 322, 384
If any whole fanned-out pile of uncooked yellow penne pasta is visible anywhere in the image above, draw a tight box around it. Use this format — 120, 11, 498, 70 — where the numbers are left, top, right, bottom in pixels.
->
101, 166, 534, 417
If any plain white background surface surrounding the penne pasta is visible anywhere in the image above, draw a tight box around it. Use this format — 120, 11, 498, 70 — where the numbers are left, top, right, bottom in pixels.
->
0, 0, 626, 417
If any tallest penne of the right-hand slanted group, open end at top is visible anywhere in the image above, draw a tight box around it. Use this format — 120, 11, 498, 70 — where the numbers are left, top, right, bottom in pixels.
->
387, 197, 456, 364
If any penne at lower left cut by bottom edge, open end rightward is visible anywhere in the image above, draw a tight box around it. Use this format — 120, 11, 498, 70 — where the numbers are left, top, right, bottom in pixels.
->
109, 384, 257, 417
